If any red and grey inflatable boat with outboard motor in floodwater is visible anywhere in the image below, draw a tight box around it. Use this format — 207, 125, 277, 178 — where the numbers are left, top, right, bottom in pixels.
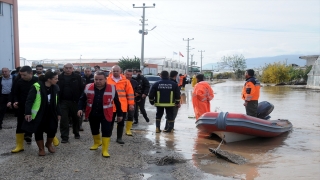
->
196, 101, 292, 143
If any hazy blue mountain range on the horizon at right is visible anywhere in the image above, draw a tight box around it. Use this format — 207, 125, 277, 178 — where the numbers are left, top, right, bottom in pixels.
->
202, 54, 306, 70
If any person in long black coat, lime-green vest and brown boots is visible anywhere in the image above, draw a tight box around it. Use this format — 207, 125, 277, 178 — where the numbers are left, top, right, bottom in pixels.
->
22, 72, 61, 156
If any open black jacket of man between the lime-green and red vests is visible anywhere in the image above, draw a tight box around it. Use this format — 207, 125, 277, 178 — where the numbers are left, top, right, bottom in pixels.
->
58, 73, 84, 103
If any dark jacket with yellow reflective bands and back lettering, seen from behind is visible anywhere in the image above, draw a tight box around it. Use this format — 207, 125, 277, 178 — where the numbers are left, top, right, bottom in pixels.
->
149, 78, 180, 107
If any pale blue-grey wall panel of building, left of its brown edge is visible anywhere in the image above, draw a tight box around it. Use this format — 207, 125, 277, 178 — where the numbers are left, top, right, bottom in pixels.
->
0, 2, 15, 70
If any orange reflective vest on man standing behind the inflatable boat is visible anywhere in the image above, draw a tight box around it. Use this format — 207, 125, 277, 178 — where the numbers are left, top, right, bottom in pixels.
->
242, 77, 260, 101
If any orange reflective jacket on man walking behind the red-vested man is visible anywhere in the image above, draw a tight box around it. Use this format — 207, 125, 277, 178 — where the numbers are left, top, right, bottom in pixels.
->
107, 73, 134, 112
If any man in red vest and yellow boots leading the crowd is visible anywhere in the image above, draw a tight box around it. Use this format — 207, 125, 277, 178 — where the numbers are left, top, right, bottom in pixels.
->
78, 71, 122, 158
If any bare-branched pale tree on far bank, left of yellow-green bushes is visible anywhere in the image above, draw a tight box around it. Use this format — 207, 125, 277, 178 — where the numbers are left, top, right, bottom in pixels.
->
220, 54, 247, 78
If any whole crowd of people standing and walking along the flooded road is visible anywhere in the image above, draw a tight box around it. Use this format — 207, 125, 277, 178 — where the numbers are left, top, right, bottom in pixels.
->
0, 63, 260, 157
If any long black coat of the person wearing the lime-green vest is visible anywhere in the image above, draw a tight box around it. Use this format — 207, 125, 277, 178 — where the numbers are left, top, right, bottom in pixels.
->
22, 81, 61, 133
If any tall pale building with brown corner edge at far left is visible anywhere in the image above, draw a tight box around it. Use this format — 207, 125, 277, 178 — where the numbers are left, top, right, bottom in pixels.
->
0, 0, 20, 70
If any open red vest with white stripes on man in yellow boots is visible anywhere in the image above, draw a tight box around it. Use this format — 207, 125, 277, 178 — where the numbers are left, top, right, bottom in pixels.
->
84, 83, 116, 122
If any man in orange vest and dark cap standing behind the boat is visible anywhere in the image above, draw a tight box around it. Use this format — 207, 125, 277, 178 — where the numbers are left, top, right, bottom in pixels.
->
242, 69, 260, 117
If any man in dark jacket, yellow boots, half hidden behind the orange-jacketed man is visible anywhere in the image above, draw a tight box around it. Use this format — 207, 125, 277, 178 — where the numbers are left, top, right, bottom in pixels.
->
124, 69, 139, 136
